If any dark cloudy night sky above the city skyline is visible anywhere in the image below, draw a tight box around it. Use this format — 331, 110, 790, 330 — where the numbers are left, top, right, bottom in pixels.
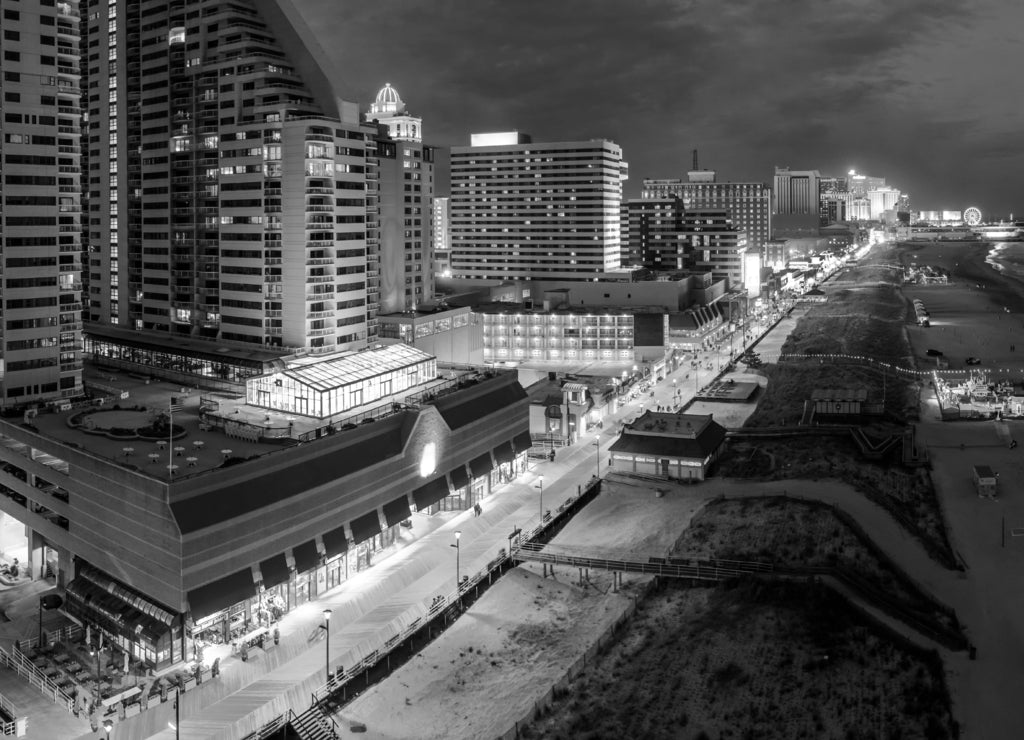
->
296, 0, 1024, 218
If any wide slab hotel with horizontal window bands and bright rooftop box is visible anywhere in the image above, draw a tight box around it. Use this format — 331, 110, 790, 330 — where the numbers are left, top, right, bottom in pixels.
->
451, 132, 628, 280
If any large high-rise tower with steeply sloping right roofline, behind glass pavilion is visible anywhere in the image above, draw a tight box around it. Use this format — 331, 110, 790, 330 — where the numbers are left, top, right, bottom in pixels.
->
82, 0, 377, 354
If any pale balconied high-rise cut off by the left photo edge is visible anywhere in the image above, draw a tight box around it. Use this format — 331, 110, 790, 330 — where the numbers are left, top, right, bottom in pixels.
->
0, 0, 82, 405
